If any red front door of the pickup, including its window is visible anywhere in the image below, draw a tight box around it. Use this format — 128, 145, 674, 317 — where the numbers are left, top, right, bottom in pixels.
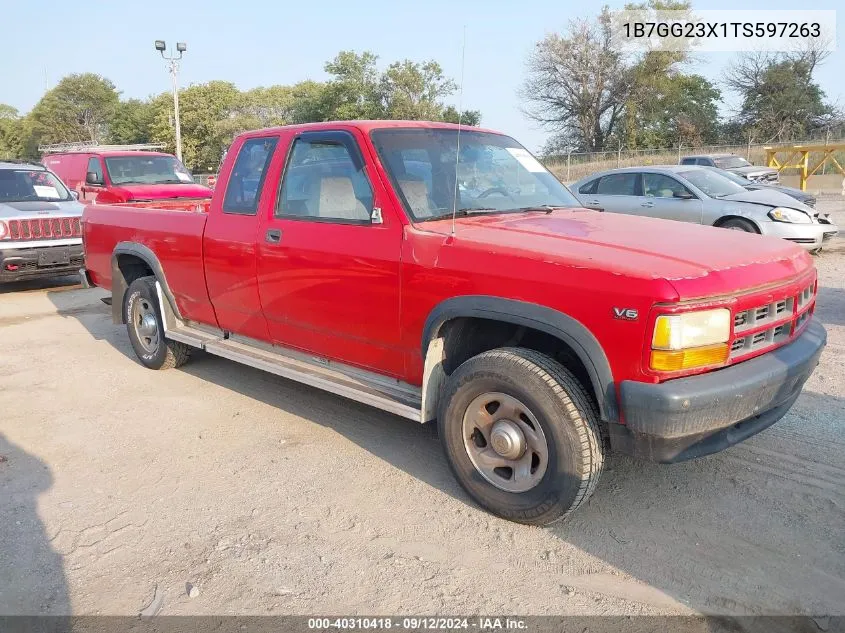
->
257, 130, 404, 376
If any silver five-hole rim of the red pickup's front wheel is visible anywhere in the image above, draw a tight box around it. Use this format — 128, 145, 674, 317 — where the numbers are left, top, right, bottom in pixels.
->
461, 392, 549, 492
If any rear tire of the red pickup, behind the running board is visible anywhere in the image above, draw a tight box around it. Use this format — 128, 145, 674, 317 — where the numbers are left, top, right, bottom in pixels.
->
123, 276, 191, 369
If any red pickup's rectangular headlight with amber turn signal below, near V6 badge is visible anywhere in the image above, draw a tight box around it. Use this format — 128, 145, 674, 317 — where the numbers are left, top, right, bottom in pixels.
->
650, 308, 731, 371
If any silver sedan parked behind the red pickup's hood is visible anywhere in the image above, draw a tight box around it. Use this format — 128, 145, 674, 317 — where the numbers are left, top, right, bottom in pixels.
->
572, 165, 838, 251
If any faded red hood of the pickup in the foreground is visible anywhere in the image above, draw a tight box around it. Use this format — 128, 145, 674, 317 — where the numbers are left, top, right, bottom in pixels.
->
418, 209, 812, 300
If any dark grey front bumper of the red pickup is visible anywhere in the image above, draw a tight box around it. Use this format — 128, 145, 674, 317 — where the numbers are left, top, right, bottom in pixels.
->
610, 319, 827, 463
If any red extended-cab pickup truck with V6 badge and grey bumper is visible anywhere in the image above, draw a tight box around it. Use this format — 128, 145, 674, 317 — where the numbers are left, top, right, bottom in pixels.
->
82, 121, 826, 524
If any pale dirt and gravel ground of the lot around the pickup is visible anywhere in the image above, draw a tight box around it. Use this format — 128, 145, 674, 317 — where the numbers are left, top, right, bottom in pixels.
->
0, 198, 845, 615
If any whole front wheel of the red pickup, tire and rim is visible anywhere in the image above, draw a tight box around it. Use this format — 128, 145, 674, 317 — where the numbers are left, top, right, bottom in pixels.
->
438, 348, 604, 525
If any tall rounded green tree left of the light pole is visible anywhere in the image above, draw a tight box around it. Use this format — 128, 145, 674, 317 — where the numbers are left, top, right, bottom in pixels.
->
30, 73, 119, 143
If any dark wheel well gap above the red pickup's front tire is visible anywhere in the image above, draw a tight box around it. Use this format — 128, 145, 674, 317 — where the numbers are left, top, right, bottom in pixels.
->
436, 317, 598, 406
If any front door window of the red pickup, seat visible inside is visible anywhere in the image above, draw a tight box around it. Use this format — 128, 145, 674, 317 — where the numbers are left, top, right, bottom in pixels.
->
276, 138, 373, 223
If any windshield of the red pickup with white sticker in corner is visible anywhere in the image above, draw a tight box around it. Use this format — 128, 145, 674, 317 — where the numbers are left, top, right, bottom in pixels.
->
372, 128, 581, 221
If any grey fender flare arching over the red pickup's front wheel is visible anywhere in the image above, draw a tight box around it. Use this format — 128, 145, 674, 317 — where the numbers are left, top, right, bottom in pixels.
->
420, 295, 619, 422
